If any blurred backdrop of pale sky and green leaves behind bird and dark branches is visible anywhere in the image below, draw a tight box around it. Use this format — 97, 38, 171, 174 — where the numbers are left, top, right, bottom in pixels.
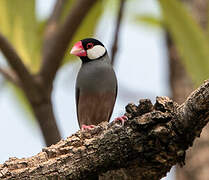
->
0, 0, 209, 180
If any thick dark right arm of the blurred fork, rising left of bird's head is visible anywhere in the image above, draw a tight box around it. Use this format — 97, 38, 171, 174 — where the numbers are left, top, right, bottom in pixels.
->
40, 0, 97, 89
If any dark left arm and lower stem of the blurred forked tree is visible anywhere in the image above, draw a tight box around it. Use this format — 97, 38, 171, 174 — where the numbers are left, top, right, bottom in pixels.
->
0, 34, 61, 145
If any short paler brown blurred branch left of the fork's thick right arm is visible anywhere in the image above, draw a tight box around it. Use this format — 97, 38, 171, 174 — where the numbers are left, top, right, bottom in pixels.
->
43, 0, 66, 52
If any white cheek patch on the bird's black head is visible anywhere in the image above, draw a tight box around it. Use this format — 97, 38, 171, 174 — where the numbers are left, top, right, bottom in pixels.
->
87, 45, 106, 59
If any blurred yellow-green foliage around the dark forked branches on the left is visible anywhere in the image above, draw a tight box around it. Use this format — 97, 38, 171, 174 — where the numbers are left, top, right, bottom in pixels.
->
0, 0, 103, 122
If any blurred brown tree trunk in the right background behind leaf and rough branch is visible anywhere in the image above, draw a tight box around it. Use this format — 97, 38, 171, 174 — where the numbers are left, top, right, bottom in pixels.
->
167, 0, 209, 180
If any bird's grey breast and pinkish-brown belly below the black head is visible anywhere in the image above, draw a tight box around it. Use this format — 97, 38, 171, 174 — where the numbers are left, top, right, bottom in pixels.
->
76, 56, 117, 127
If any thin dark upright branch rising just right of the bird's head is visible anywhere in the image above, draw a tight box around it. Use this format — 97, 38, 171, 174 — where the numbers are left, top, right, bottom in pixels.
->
111, 0, 125, 66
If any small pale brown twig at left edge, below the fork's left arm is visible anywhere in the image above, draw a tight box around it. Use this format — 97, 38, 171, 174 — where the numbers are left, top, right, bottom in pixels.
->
0, 67, 21, 87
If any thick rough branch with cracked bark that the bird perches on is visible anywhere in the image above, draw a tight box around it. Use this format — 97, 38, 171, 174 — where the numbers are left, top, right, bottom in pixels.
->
0, 80, 209, 180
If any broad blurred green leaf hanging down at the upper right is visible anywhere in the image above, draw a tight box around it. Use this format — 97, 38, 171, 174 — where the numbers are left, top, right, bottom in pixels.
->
159, 0, 209, 85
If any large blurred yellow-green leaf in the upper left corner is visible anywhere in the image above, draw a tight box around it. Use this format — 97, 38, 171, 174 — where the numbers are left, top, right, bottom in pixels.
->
0, 0, 40, 71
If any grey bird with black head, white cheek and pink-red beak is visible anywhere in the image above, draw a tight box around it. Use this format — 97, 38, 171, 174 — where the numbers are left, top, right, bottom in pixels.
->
70, 38, 126, 130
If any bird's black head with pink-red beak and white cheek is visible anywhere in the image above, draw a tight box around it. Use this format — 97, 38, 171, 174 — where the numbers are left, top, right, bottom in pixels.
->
70, 38, 107, 62
